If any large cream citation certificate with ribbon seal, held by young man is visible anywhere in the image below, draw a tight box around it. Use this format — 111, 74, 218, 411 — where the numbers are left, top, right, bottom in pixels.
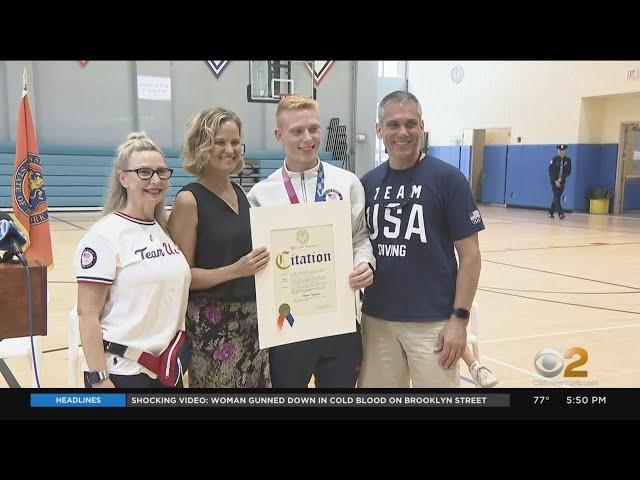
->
249, 201, 356, 349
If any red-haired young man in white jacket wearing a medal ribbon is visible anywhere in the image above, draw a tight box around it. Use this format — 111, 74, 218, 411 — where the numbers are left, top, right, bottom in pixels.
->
248, 95, 375, 388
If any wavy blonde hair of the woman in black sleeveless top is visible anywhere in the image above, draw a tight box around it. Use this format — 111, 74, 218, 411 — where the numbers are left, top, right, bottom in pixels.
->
182, 108, 245, 176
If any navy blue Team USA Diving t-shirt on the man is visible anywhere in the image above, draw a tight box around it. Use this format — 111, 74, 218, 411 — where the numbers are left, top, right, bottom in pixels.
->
361, 156, 484, 322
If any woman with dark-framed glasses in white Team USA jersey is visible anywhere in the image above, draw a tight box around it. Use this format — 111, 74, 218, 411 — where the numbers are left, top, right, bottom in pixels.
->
74, 132, 191, 388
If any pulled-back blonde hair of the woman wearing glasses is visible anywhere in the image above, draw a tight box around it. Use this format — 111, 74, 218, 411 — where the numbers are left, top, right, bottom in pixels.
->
102, 132, 167, 231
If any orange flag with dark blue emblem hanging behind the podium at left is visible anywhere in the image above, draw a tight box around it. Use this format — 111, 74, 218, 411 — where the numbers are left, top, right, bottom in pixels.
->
11, 81, 53, 268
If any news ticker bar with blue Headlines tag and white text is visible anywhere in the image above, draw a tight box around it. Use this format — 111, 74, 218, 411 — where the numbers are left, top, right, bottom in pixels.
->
31, 393, 511, 408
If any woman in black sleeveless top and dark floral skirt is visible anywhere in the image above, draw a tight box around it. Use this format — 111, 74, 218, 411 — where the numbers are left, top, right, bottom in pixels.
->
169, 108, 271, 388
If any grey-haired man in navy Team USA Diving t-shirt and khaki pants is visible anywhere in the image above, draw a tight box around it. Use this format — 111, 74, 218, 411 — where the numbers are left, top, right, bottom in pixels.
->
358, 91, 484, 387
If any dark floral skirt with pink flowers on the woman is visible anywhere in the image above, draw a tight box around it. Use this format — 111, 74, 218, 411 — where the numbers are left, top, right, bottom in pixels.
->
186, 297, 271, 388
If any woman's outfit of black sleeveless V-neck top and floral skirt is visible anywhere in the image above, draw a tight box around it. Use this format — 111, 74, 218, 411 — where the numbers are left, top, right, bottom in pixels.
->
181, 182, 271, 388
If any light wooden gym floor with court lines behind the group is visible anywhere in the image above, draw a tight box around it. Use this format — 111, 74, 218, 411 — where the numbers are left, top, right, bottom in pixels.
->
0, 205, 640, 388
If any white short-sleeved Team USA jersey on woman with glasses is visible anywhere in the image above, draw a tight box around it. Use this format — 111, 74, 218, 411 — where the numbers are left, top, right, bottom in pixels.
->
74, 212, 191, 377
